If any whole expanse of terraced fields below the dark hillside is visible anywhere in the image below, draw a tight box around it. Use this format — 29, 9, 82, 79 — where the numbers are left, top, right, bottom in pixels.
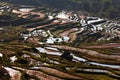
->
0, 3, 120, 80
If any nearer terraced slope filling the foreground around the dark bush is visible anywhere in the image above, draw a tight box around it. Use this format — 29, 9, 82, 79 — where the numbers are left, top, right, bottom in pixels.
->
0, 44, 120, 80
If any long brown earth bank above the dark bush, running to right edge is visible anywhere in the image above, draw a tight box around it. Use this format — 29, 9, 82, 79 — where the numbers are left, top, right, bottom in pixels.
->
47, 45, 120, 64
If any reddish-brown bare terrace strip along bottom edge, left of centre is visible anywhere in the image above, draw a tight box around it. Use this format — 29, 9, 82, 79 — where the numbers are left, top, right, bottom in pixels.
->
14, 67, 83, 80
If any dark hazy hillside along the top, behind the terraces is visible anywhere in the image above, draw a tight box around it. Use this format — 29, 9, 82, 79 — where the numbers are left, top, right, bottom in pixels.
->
0, 0, 120, 18
